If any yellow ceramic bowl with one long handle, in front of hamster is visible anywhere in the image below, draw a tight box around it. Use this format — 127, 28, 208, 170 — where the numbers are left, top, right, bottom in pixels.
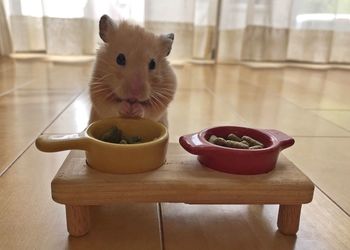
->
35, 118, 169, 174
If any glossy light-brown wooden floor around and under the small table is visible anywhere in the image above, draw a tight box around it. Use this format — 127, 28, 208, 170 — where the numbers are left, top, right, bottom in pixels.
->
0, 58, 350, 250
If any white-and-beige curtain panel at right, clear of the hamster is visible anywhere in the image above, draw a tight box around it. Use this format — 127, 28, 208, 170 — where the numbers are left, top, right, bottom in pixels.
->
218, 0, 350, 63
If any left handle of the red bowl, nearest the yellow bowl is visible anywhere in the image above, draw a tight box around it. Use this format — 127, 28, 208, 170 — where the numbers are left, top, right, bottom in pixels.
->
179, 133, 216, 155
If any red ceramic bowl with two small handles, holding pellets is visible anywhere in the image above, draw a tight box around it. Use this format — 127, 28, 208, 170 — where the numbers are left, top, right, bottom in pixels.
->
179, 126, 294, 175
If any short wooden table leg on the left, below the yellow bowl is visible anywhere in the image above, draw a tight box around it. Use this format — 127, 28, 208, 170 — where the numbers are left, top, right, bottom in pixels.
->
66, 205, 90, 236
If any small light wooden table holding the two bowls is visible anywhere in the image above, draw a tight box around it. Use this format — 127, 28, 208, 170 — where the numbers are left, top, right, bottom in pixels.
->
51, 143, 314, 236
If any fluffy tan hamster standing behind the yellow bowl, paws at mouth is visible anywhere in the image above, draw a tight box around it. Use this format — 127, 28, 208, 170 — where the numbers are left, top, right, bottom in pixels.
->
89, 15, 176, 126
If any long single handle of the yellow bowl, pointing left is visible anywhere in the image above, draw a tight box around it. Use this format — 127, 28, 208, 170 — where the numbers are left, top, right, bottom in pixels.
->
35, 132, 90, 152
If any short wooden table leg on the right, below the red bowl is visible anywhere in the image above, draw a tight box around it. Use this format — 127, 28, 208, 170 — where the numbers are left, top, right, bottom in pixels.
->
277, 204, 301, 235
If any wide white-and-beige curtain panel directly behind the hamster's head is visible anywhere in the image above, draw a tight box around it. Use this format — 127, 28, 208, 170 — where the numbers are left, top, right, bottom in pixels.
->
4, 0, 218, 60
